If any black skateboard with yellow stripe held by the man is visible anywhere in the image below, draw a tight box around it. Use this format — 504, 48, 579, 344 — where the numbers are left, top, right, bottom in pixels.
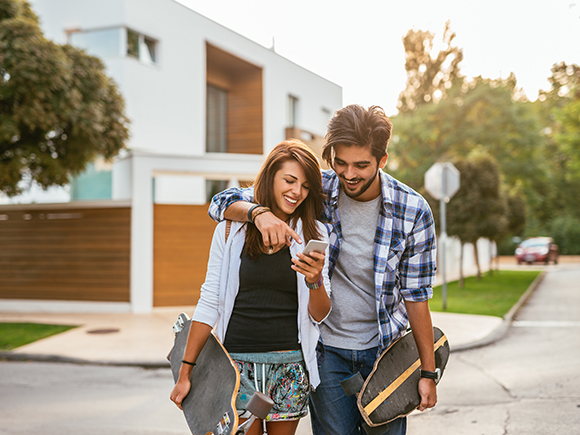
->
342, 327, 449, 433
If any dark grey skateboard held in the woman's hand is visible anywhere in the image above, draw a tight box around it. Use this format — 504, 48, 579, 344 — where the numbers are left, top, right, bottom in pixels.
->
169, 313, 274, 435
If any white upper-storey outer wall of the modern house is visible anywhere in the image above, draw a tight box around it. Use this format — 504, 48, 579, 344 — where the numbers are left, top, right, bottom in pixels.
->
32, 0, 342, 161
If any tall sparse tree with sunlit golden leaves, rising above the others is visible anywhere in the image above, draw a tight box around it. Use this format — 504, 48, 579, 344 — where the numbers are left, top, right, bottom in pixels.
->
397, 21, 463, 112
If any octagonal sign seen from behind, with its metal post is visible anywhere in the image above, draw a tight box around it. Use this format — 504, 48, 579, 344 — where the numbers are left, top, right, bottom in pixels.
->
425, 162, 460, 311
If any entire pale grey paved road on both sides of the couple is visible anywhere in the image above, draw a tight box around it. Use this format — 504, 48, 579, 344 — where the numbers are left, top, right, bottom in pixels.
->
0, 264, 580, 435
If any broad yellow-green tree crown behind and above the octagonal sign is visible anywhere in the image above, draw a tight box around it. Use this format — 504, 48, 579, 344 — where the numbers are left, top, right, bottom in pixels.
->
389, 75, 543, 194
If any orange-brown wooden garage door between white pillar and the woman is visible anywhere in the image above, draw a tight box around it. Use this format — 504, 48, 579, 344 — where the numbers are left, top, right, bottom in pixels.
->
153, 204, 216, 307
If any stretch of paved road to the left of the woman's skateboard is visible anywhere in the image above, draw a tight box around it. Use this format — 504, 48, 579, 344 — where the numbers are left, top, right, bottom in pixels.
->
0, 362, 190, 435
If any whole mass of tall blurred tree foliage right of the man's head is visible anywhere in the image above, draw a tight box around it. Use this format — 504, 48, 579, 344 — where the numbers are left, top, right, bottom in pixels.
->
388, 26, 580, 254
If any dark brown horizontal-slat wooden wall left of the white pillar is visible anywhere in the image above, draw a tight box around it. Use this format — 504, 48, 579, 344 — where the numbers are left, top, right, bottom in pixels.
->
0, 207, 131, 302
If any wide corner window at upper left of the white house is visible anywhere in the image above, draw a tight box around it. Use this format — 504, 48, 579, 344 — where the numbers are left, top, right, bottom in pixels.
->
68, 27, 157, 64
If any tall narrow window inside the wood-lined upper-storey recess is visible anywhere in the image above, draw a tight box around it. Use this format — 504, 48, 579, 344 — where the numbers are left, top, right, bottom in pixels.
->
205, 84, 228, 153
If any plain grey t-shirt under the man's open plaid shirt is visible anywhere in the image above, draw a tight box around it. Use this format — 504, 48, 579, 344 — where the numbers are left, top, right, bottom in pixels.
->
320, 190, 382, 350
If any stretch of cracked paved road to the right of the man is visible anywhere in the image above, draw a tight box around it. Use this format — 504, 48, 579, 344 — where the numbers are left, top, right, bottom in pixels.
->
408, 265, 580, 435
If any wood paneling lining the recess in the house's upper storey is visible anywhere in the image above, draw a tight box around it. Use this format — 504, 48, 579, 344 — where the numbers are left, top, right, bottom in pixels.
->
206, 44, 264, 154
